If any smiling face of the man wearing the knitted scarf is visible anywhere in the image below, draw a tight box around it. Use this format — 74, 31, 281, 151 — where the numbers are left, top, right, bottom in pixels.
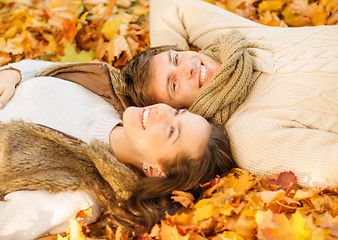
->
148, 50, 221, 108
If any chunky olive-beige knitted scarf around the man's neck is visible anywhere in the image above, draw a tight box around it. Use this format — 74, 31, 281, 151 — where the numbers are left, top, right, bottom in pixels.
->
189, 30, 259, 126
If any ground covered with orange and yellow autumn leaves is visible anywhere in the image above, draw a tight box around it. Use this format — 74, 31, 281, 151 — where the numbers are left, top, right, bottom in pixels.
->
0, 0, 338, 240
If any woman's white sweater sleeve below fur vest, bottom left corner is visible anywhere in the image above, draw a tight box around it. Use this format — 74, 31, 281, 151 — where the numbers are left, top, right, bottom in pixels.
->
0, 191, 100, 240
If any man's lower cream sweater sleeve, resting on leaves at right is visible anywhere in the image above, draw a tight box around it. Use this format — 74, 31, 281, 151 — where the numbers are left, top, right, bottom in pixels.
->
228, 118, 338, 187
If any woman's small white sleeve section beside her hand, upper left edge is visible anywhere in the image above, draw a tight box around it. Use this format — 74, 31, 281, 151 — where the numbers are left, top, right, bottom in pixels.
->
0, 59, 58, 81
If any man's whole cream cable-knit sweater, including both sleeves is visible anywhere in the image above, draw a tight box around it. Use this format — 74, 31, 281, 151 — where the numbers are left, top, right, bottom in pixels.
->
150, 0, 338, 187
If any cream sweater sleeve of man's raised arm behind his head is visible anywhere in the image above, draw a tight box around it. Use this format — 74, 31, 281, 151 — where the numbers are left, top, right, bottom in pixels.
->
150, 0, 266, 50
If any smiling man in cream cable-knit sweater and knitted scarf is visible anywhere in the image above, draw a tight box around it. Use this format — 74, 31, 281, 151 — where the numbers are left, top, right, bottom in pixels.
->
124, 0, 338, 187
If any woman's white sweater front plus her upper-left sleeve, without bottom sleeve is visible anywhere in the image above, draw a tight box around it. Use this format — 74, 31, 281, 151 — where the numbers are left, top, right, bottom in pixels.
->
0, 60, 122, 143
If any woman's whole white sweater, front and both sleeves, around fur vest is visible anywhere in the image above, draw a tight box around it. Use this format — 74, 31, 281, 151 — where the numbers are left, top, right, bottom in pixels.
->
0, 60, 121, 240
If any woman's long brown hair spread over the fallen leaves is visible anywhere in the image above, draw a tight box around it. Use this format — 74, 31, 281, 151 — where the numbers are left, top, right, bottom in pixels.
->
110, 124, 235, 233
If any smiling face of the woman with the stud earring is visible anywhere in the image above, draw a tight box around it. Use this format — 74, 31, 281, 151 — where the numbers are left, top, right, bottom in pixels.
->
123, 104, 211, 168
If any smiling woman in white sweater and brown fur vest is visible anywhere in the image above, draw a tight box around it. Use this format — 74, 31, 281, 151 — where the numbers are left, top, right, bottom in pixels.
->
0, 60, 235, 239
